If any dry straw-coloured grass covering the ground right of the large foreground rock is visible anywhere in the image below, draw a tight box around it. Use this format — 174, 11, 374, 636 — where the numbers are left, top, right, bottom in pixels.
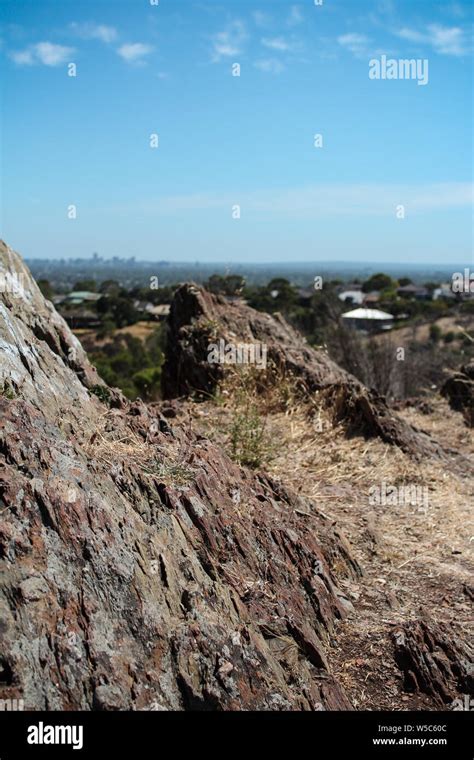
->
186, 374, 474, 710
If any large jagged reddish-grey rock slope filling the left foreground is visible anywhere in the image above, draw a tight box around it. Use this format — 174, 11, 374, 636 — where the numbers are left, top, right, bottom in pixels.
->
0, 240, 359, 710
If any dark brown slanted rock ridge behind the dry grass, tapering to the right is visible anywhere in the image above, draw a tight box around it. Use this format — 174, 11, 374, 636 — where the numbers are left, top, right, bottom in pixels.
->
163, 284, 443, 458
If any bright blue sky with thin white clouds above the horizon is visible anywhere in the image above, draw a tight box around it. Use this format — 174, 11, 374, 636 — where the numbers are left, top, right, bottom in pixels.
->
0, 0, 473, 264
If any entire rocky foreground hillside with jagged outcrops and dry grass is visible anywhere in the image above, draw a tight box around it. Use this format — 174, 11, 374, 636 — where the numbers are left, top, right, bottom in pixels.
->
0, 243, 473, 710
